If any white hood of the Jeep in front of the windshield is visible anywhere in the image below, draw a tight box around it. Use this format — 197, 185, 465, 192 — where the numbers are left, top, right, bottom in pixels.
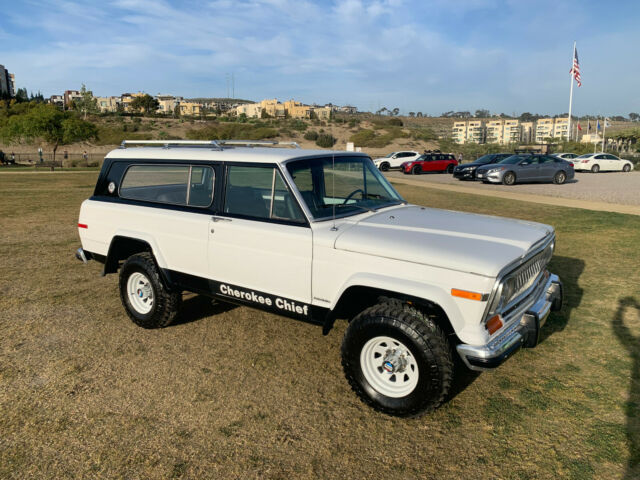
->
334, 205, 553, 277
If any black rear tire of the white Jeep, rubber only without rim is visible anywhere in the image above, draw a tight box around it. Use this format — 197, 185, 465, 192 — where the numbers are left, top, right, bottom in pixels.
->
119, 252, 182, 328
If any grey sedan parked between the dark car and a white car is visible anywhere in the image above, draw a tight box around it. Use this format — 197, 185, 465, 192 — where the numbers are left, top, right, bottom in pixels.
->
476, 155, 575, 185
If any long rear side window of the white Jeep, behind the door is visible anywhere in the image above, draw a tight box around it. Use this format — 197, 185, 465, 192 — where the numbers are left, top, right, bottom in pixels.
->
120, 165, 214, 207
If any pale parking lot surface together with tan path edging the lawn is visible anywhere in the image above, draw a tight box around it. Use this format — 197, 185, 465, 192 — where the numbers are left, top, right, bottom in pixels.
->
385, 172, 640, 215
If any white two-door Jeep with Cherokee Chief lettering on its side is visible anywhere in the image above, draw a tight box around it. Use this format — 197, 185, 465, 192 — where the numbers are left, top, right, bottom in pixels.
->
76, 141, 562, 416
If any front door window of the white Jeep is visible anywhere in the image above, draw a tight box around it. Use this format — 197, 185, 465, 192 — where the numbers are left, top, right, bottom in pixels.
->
224, 165, 304, 222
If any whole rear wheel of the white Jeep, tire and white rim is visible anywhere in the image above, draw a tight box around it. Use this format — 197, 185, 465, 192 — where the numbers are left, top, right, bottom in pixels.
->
120, 252, 182, 328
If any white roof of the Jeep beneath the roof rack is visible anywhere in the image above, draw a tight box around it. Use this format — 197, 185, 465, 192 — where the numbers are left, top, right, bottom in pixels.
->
105, 147, 368, 163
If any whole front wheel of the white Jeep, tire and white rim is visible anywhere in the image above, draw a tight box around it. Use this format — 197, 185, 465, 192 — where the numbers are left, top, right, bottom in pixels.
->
342, 301, 453, 417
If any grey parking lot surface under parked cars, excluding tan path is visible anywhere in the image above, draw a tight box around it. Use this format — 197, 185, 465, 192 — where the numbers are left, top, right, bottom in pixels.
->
385, 171, 640, 206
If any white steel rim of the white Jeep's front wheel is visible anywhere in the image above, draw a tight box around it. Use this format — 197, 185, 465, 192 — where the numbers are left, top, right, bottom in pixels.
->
360, 337, 419, 398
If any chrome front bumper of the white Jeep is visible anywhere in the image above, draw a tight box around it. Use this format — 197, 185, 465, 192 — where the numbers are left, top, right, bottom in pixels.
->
456, 274, 563, 371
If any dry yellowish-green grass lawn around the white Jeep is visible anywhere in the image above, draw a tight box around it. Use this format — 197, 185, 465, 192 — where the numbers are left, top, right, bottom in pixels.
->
0, 172, 640, 480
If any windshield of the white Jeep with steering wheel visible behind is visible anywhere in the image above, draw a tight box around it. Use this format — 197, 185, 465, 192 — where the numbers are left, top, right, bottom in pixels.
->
287, 156, 404, 220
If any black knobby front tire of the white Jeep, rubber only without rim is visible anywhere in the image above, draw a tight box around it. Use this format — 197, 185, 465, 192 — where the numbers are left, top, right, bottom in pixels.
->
341, 300, 453, 417
